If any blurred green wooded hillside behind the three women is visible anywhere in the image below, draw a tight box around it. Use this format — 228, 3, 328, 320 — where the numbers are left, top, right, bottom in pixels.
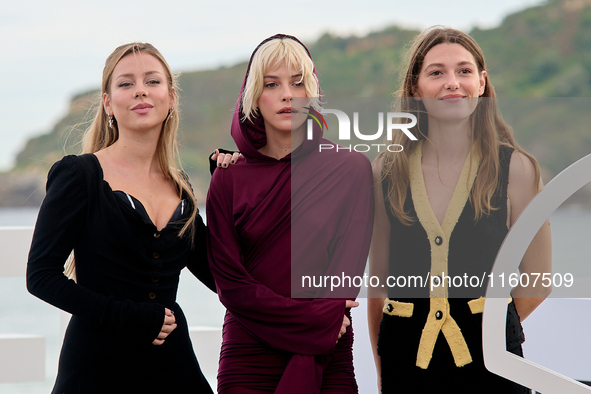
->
13, 0, 591, 203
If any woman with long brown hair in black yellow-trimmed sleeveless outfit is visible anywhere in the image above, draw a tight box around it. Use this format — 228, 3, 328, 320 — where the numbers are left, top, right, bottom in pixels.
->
368, 28, 551, 394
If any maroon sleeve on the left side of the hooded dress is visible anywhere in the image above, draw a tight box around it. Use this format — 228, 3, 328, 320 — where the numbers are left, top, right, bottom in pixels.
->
207, 171, 345, 355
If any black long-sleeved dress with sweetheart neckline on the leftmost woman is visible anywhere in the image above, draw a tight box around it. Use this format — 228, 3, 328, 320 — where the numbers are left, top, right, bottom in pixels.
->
27, 154, 215, 393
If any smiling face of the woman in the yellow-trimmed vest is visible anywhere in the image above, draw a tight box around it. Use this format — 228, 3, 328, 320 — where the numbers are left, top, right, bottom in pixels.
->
414, 44, 486, 120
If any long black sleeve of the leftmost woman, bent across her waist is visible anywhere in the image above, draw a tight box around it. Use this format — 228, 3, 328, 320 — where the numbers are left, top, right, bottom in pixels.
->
27, 156, 164, 343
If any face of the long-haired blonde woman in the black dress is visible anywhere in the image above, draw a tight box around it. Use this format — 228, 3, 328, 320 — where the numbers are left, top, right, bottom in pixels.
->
103, 52, 174, 132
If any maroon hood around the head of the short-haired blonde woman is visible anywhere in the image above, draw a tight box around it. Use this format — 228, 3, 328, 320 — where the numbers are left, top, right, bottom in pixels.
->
231, 34, 322, 161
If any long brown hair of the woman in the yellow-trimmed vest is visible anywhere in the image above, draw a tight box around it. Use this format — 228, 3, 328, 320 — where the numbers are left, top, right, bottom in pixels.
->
379, 27, 540, 225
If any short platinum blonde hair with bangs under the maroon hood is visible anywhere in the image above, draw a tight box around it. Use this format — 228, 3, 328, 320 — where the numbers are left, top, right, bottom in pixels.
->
242, 37, 320, 122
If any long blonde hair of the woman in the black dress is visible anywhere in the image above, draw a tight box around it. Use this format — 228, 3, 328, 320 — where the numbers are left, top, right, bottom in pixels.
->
65, 42, 198, 277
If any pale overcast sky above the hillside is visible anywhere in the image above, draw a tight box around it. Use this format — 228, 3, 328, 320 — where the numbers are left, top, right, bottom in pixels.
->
0, 0, 544, 171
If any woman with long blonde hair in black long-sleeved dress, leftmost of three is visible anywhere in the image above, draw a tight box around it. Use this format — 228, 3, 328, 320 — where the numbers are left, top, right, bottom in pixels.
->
27, 43, 223, 394
